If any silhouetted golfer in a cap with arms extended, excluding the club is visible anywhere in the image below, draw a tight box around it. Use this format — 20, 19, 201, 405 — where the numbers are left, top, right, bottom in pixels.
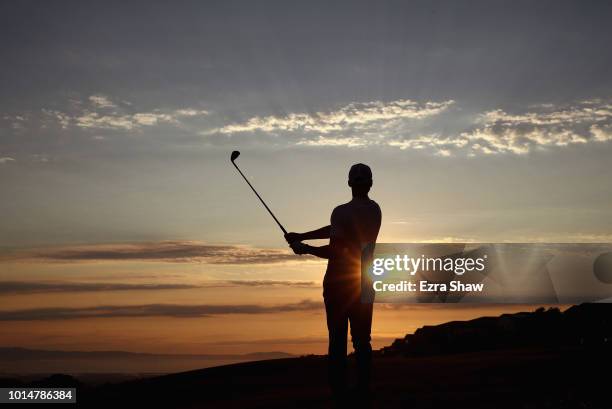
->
285, 163, 382, 397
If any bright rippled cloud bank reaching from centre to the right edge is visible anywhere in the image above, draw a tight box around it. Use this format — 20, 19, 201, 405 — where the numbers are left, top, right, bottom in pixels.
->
214, 99, 612, 157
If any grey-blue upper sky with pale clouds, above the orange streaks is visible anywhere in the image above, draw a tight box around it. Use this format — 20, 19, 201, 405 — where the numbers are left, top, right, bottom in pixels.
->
0, 1, 612, 247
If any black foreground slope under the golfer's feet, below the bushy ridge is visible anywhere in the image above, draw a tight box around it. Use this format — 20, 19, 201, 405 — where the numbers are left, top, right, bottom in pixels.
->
79, 349, 612, 409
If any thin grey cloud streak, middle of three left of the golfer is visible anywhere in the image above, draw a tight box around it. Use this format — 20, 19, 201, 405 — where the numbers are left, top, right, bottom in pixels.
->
0, 280, 320, 295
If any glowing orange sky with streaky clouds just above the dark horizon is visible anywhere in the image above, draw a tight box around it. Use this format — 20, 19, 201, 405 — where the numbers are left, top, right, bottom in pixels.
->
0, 249, 560, 354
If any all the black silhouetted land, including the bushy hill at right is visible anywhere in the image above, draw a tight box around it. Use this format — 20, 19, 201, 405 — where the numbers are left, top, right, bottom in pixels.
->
5, 304, 612, 409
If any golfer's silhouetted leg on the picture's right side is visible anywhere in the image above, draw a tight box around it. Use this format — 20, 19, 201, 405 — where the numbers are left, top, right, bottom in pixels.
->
349, 300, 373, 392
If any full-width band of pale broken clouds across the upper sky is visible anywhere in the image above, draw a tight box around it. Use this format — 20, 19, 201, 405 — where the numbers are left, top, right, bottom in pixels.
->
5, 94, 612, 157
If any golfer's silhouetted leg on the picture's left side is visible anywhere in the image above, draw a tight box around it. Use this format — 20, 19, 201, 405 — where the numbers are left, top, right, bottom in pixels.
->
325, 296, 348, 396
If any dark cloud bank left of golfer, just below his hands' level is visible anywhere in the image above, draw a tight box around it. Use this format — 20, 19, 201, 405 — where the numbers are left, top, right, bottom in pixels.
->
0, 241, 310, 264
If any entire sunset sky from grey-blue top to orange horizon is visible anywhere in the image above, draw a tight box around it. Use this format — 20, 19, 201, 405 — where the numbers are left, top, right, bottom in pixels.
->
0, 1, 612, 362
